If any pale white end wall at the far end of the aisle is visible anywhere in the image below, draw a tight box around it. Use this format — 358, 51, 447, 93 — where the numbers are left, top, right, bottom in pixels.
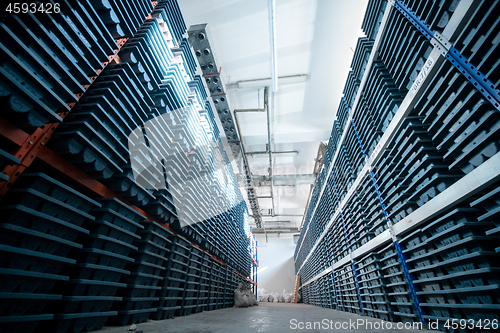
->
255, 233, 295, 293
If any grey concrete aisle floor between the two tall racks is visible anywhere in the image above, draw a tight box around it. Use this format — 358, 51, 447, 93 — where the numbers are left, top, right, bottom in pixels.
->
99, 303, 436, 333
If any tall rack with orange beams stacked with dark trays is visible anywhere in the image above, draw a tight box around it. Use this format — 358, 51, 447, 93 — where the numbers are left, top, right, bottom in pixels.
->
0, 0, 256, 332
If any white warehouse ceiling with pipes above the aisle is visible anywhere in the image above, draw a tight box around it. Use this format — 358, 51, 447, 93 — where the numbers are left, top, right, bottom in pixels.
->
179, 0, 368, 230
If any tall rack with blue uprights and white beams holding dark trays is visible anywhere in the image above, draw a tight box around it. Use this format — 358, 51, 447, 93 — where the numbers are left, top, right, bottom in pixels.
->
295, 0, 500, 328
